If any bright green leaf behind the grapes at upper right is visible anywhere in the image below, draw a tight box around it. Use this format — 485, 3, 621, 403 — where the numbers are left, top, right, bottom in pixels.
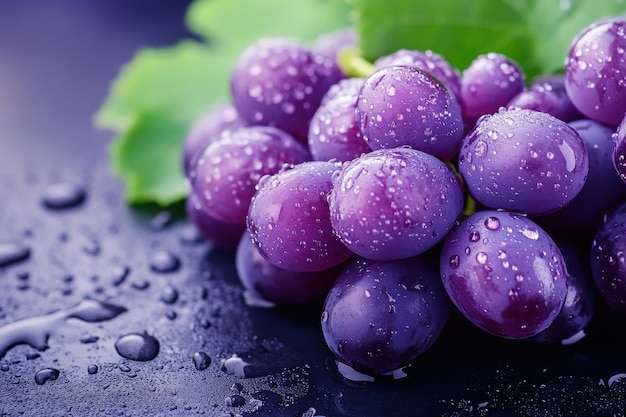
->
351, 0, 626, 79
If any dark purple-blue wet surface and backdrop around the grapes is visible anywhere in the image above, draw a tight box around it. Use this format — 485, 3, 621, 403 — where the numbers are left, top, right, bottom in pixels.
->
0, 0, 626, 417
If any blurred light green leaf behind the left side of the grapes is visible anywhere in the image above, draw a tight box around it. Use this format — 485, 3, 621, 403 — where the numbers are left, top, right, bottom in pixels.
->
94, 0, 349, 206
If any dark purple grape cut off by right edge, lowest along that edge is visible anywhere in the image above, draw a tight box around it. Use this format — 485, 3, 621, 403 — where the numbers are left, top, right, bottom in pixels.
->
590, 203, 626, 314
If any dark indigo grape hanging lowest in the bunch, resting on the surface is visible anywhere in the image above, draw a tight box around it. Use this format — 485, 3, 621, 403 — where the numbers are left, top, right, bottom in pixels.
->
321, 254, 451, 376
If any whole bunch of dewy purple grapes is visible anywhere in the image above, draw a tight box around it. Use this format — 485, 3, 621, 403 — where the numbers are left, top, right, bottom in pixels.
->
183, 18, 626, 376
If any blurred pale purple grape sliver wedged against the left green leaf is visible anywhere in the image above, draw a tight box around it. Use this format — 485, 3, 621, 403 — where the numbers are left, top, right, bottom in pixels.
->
183, 103, 244, 176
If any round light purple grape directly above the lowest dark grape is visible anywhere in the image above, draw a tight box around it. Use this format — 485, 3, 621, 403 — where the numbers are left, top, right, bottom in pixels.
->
329, 148, 463, 260
